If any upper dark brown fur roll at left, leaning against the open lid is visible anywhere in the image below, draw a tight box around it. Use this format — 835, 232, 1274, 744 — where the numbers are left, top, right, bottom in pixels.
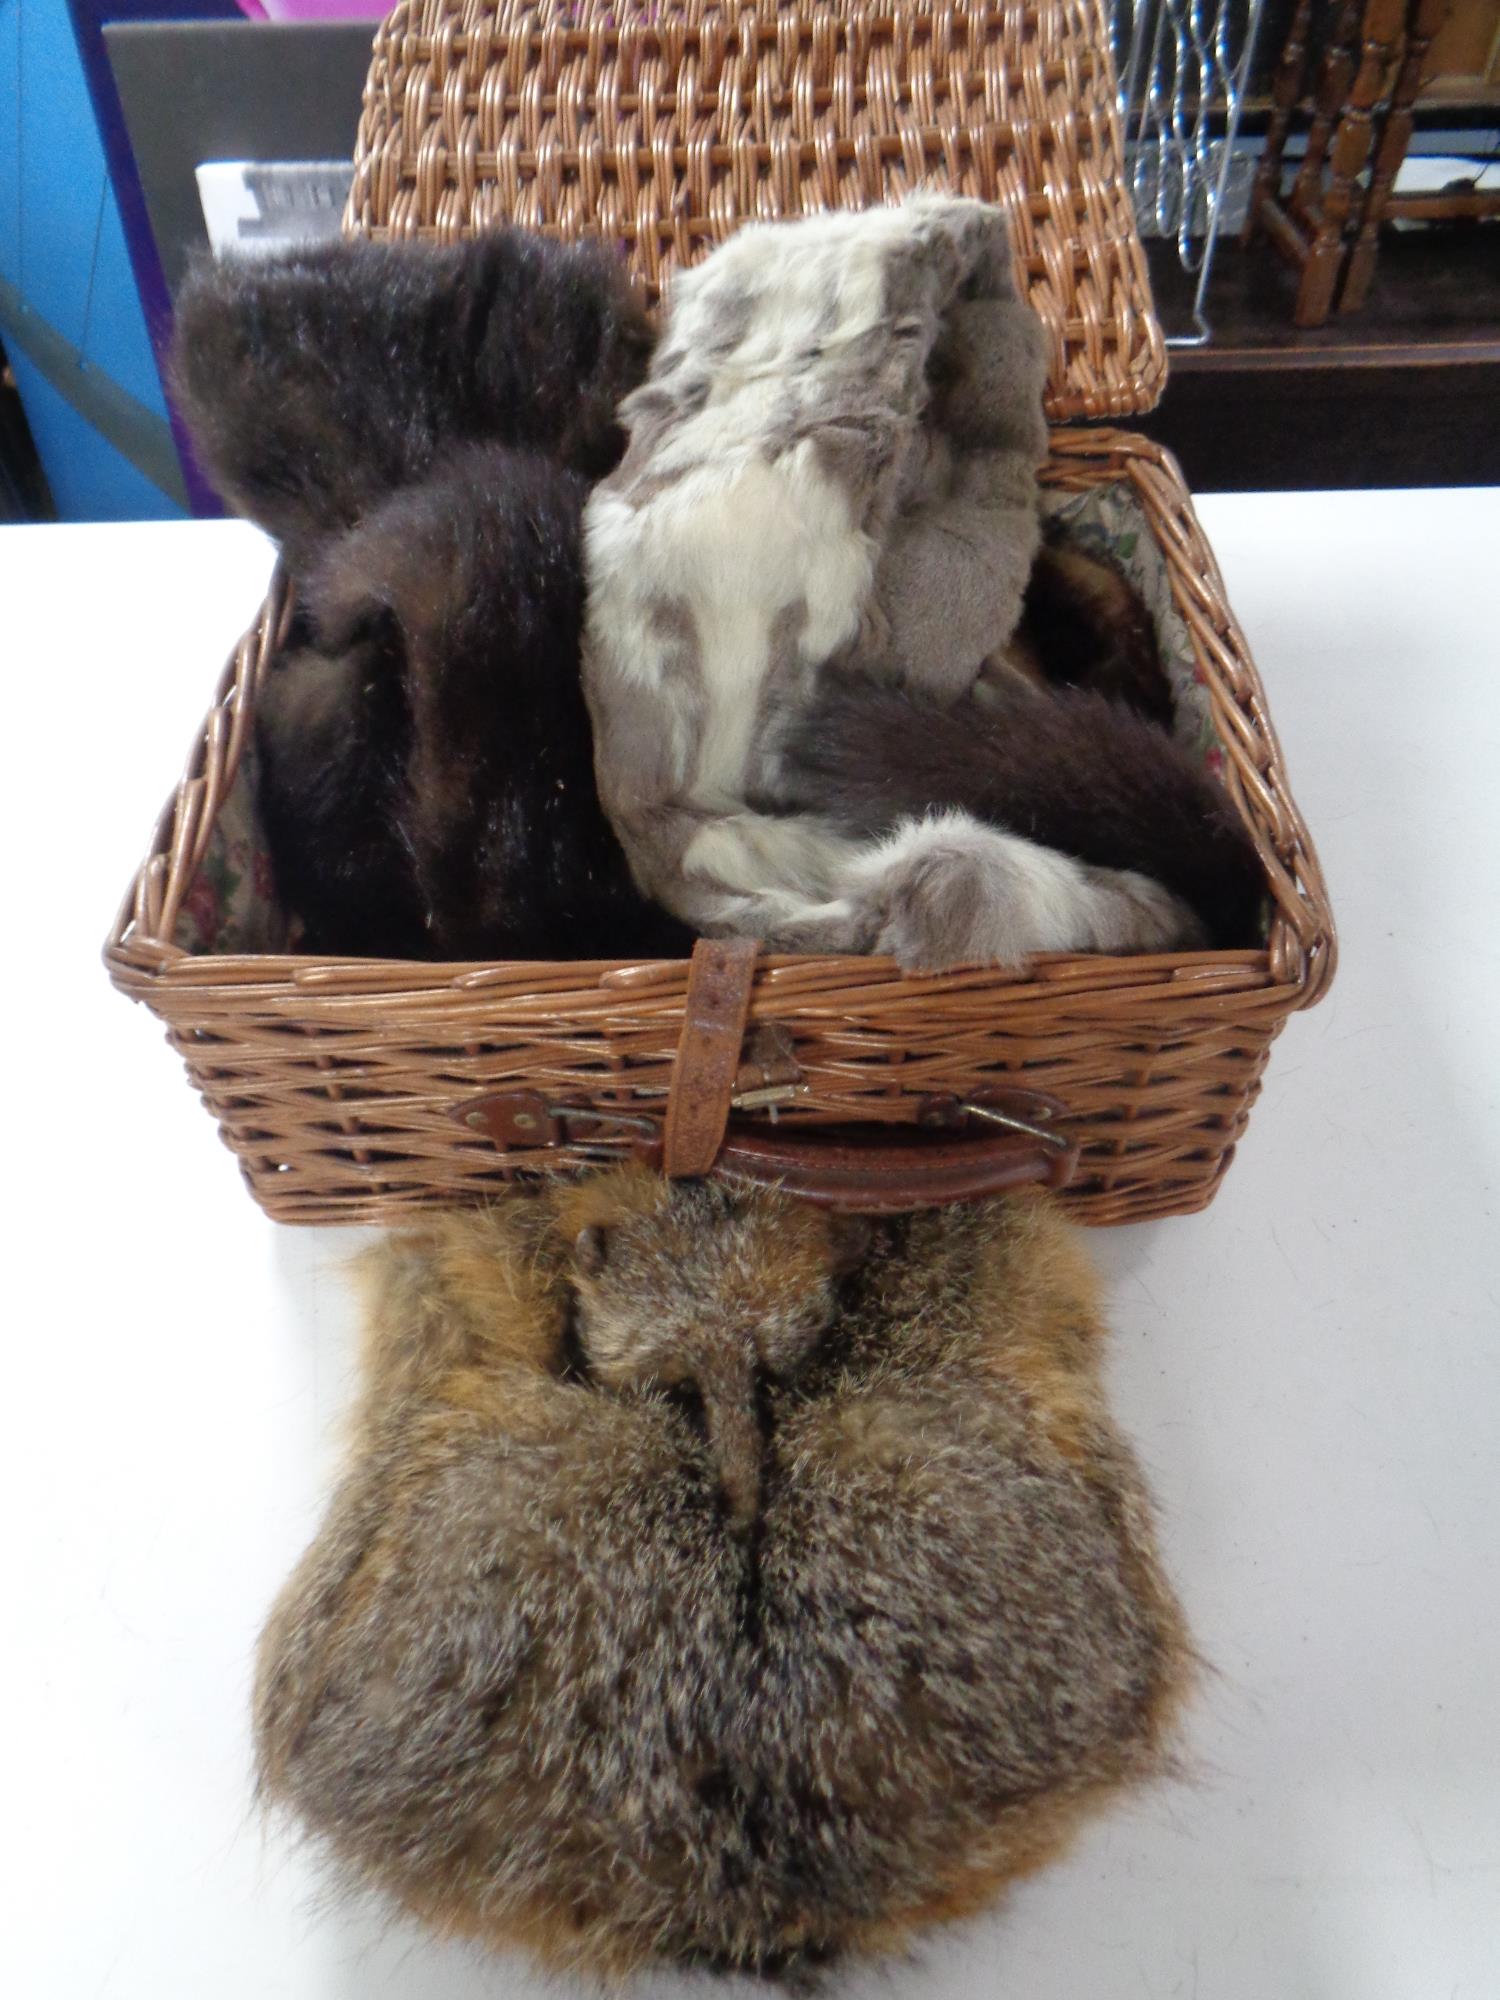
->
172, 230, 652, 560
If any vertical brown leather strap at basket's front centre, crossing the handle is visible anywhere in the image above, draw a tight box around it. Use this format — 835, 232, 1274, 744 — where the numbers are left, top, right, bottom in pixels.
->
662, 938, 760, 1180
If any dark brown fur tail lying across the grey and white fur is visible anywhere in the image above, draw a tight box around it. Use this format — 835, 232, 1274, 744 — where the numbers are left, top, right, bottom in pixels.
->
784, 682, 1266, 950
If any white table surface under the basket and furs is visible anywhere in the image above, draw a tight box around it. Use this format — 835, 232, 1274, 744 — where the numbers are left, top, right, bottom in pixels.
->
0, 492, 1500, 2000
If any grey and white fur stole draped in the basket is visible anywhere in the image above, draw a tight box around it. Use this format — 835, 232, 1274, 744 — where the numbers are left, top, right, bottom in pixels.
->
584, 196, 1200, 970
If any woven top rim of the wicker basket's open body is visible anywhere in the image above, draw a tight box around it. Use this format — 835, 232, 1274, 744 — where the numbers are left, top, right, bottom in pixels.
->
104, 428, 1338, 1022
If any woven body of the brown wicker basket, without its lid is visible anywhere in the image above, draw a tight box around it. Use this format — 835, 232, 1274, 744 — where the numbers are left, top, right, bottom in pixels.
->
108, 416, 1334, 1222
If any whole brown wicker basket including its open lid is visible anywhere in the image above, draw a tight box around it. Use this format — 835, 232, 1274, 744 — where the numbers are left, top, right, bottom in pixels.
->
106, 0, 1336, 1222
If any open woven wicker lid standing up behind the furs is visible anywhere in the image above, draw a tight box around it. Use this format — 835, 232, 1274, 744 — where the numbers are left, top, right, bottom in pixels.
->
346, 0, 1166, 420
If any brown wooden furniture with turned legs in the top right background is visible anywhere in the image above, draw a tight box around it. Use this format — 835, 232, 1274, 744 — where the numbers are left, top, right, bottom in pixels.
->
1244, 0, 1500, 326
